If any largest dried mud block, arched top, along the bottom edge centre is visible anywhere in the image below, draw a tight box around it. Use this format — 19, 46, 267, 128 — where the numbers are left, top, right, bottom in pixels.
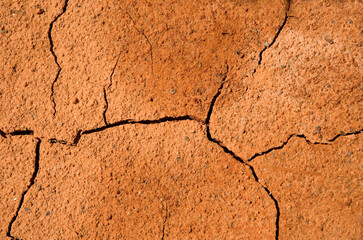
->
13, 121, 276, 239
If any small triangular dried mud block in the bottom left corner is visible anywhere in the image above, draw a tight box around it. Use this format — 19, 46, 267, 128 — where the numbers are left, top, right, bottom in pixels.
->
0, 137, 36, 239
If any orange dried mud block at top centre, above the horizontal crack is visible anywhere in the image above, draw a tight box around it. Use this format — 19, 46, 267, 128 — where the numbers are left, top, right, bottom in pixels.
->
107, 0, 285, 122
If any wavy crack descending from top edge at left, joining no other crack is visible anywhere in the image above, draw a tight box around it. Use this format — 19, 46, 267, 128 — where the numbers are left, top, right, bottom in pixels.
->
48, 0, 69, 116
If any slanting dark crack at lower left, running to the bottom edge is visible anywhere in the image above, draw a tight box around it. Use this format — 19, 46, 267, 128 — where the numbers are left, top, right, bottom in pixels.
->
6, 138, 42, 240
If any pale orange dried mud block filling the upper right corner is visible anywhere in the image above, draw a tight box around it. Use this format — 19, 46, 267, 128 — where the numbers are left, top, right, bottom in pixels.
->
211, 1, 363, 160
